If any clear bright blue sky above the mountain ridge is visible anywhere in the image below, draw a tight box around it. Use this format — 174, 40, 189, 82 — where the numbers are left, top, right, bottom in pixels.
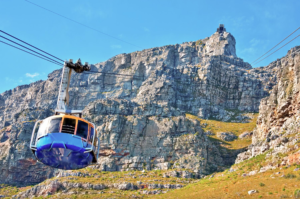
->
0, 0, 300, 93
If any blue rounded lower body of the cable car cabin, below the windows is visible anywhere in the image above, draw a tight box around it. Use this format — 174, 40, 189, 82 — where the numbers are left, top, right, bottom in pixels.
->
35, 133, 94, 170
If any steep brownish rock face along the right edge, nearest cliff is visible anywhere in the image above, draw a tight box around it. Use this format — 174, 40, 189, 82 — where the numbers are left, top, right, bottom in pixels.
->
236, 46, 300, 166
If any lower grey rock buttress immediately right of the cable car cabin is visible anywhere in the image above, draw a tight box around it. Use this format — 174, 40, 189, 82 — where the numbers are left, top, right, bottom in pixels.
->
84, 100, 226, 175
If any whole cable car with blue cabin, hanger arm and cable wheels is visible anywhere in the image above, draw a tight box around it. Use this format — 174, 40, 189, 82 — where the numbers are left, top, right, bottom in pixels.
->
30, 59, 100, 170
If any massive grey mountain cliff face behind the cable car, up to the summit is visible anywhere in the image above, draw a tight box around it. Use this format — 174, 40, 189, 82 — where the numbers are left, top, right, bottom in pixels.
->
0, 27, 276, 184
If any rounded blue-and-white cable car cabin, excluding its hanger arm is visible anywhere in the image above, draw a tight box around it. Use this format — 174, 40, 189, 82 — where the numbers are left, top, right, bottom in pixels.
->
30, 115, 100, 170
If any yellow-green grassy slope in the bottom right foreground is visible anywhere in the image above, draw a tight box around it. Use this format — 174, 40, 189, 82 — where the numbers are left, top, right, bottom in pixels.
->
151, 155, 300, 199
